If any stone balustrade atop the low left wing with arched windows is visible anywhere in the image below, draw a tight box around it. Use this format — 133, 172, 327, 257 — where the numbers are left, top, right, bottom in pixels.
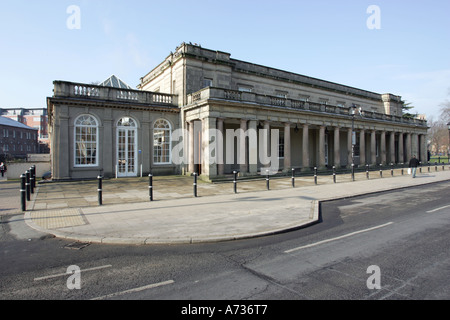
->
53, 81, 177, 106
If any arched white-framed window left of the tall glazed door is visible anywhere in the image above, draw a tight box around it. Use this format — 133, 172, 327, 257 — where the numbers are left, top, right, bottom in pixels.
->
74, 114, 98, 167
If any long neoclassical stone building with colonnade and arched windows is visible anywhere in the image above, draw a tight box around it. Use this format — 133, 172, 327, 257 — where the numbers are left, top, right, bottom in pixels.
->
47, 43, 427, 180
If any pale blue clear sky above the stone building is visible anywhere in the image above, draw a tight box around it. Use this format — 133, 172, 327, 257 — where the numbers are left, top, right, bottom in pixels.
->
0, 0, 450, 119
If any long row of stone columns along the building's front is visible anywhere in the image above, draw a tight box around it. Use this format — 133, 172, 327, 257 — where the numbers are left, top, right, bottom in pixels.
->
186, 117, 427, 176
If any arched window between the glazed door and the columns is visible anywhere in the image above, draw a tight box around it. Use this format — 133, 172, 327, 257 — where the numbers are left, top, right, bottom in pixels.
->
153, 119, 172, 164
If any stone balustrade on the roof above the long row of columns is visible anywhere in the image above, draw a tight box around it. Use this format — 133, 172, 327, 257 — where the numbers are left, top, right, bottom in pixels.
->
188, 87, 427, 127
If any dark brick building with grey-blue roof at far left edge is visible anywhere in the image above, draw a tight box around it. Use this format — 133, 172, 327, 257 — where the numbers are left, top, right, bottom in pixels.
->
0, 117, 39, 159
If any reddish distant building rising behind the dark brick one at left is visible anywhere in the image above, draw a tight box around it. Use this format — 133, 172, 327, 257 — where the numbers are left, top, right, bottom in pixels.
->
0, 108, 50, 153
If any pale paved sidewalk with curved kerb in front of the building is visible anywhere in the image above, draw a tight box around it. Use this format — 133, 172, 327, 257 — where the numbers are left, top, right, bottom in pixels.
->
25, 166, 450, 244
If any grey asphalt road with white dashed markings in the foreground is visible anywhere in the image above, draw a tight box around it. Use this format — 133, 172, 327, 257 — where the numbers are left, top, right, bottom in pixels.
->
0, 182, 450, 308
